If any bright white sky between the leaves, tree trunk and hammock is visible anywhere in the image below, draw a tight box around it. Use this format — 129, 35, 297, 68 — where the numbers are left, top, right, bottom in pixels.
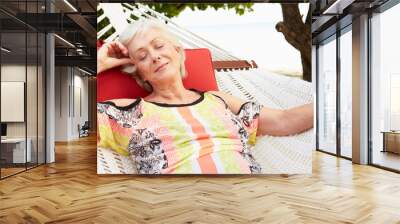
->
172, 3, 309, 72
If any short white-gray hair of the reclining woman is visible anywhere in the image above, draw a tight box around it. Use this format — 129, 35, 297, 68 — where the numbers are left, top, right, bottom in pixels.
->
118, 19, 186, 91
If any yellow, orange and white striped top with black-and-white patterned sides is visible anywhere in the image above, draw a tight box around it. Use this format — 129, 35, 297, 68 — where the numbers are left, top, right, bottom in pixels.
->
97, 92, 261, 174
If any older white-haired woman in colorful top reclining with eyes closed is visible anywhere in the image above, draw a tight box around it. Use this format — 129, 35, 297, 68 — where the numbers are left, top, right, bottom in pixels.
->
97, 20, 313, 174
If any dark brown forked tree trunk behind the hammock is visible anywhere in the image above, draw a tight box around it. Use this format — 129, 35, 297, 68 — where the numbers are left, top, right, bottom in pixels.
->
275, 3, 311, 82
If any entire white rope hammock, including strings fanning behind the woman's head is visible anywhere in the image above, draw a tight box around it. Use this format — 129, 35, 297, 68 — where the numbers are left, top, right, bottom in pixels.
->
97, 3, 315, 174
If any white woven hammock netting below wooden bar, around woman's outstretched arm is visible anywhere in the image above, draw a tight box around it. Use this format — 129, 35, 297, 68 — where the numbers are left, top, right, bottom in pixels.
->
97, 69, 314, 174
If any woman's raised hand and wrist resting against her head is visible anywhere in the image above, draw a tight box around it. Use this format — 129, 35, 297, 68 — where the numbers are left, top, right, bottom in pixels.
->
97, 41, 131, 74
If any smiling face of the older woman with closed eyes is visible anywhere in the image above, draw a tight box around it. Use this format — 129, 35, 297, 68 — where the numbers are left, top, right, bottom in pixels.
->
128, 28, 180, 84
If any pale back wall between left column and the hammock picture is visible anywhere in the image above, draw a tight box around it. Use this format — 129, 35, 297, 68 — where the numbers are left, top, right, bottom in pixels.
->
55, 67, 88, 141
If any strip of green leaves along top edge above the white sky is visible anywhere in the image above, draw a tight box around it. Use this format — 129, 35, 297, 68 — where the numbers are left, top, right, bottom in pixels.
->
141, 3, 254, 18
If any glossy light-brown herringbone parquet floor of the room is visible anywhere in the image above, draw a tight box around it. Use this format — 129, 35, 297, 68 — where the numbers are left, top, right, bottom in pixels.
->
0, 134, 400, 224
